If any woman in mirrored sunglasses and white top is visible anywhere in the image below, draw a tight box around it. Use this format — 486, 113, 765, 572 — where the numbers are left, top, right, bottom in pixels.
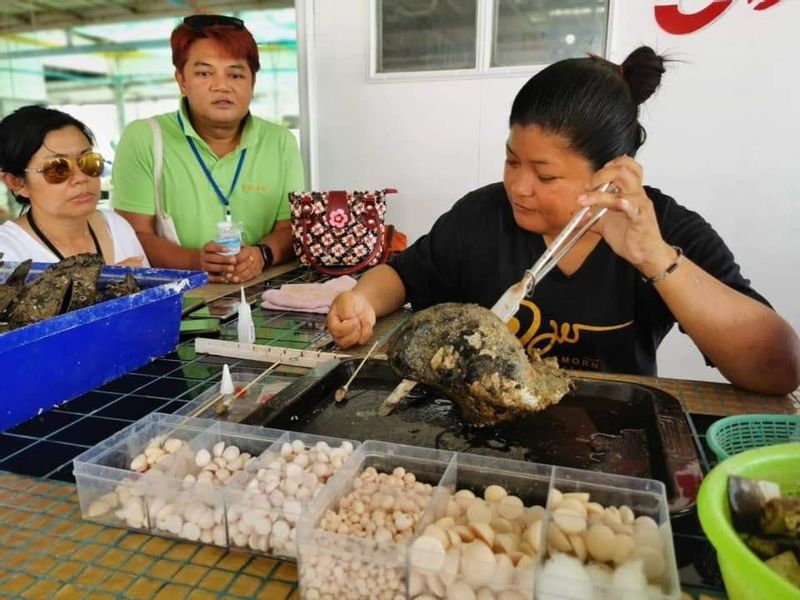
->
0, 106, 149, 267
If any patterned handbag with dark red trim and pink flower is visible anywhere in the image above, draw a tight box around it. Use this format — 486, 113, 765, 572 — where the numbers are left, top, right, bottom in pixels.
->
289, 189, 397, 275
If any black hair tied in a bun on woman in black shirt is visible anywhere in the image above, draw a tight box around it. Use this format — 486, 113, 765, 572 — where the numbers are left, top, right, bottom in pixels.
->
509, 46, 664, 169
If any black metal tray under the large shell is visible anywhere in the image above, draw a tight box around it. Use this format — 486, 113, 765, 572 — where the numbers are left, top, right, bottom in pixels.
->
255, 359, 702, 516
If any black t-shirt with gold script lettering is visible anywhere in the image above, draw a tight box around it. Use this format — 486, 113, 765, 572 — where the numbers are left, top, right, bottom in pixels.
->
390, 183, 768, 375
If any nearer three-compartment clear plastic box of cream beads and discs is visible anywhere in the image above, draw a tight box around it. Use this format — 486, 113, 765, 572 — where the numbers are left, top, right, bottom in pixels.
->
298, 442, 680, 600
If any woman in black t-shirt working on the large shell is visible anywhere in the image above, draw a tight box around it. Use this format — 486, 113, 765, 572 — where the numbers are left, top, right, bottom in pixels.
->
328, 47, 800, 394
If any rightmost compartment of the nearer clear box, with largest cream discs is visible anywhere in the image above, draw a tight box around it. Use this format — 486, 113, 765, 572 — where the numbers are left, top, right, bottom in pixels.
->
536, 467, 680, 600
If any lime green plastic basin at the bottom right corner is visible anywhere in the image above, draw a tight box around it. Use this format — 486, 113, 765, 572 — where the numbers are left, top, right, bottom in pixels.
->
697, 443, 800, 600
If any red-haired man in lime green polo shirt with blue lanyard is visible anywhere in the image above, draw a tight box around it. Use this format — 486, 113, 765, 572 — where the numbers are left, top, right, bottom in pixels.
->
112, 15, 304, 282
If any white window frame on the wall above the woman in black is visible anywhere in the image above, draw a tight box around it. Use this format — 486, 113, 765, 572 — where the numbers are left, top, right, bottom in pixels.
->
367, 0, 618, 83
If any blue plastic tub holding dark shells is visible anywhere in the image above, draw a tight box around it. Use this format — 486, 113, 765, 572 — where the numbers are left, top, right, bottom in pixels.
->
0, 263, 208, 431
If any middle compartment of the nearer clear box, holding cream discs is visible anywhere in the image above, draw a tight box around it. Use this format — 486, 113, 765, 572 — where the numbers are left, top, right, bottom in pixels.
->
408, 454, 552, 600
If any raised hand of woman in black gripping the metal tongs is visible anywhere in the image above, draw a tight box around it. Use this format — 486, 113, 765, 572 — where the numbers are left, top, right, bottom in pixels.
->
578, 156, 675, 277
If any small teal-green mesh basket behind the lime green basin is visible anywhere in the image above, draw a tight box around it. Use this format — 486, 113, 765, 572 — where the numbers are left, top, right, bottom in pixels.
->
706, 414, 800, 461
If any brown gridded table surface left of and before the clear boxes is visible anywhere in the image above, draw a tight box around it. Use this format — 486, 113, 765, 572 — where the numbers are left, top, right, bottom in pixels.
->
0, 472, 297, 600
